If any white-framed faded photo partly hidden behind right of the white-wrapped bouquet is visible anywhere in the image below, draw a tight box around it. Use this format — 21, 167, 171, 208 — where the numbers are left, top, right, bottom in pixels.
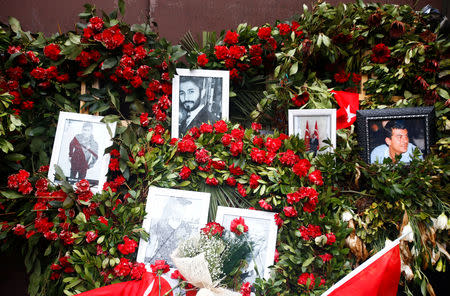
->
216, 206, 278, 283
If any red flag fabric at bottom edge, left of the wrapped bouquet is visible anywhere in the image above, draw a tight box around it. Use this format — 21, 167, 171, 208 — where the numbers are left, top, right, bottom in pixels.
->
78, 272, 173, 296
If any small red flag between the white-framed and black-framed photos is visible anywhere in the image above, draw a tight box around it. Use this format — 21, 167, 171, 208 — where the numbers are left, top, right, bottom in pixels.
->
331, 90, 359, 129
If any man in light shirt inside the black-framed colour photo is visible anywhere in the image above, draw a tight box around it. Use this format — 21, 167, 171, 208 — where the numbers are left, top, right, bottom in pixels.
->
370, 120, 423, 163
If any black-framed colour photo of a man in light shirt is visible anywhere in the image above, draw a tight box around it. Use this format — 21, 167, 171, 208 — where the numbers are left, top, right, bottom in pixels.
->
356, 107, 435, 164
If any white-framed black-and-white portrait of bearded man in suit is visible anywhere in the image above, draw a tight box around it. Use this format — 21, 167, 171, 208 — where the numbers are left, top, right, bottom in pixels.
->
172, 69, 230, 138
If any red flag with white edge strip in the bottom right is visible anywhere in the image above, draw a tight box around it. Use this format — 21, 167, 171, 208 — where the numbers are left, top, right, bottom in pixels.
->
322, 239, 401, 296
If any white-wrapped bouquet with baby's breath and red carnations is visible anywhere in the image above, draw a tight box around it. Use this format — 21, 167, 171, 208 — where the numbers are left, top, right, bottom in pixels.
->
172, 218, 252, 295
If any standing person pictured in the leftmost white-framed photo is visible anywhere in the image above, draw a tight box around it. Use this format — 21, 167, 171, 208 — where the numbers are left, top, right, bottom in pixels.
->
69, 122, 98, 181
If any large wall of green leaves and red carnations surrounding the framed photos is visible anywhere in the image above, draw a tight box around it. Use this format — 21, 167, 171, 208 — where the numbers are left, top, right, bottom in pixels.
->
0, 1, 450, 296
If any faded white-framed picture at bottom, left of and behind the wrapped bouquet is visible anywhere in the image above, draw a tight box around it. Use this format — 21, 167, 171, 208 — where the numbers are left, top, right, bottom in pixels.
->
137, 187, 211, 270
